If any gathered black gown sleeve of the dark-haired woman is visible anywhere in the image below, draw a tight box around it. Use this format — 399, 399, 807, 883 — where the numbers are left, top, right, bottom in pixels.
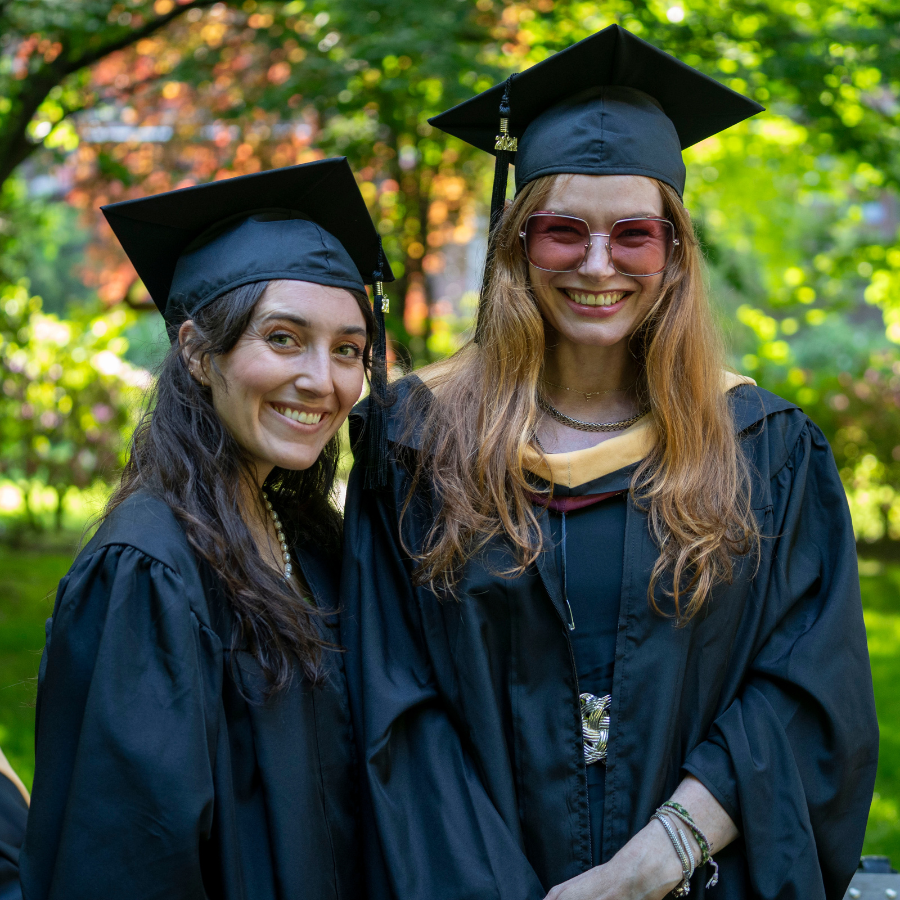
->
21, 545, 221, 900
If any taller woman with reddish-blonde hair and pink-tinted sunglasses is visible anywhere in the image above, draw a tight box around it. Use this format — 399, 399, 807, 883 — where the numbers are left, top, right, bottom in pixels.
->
342, 26, 878, 900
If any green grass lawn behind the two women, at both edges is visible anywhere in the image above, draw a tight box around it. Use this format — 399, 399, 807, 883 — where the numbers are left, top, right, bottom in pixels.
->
0, 548, 900, 868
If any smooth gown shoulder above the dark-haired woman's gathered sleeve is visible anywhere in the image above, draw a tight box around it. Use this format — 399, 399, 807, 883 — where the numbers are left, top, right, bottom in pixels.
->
79, 490, 197, 576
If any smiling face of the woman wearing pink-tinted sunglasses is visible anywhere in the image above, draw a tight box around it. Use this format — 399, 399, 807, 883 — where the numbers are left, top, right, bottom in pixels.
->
529, 175, 665, 347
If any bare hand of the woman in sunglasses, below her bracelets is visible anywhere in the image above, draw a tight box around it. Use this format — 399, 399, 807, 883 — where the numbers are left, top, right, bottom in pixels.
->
545, 819, 681, 900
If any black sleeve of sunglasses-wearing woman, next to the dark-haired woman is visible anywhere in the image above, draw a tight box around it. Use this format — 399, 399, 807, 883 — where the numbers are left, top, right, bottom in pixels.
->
341, 463, 546, 900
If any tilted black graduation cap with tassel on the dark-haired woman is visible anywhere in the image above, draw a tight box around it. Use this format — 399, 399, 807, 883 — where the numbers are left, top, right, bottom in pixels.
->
102, 157, 394, 483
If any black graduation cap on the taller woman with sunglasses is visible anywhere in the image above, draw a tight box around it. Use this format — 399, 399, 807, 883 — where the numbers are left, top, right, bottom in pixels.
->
429, 25, 763, 232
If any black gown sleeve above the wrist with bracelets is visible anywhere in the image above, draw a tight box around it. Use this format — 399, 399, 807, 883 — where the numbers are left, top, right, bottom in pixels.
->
684, 423, 878, 900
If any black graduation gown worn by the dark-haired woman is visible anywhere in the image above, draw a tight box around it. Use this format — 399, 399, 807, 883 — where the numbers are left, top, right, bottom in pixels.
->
20, 493, 362, 900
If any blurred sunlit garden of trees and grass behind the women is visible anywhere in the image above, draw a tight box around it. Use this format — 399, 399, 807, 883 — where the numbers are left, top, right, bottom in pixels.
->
0, 0, 900, 864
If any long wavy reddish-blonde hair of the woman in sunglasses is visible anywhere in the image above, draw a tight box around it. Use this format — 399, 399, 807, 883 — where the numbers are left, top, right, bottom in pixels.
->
404, 175, 759, 624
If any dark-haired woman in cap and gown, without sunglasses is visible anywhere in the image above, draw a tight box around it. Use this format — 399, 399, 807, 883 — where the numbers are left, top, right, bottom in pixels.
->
21, 159, 391, 900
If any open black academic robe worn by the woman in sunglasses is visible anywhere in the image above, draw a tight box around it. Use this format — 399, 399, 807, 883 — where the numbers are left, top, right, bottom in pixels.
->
342, 378, 878, 900
